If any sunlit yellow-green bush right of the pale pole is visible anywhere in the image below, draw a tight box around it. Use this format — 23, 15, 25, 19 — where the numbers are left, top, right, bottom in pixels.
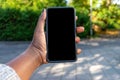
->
92, 0, 120, 29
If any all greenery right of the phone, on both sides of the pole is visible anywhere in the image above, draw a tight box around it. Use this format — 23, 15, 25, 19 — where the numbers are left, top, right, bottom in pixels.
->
70, 0, 120, 37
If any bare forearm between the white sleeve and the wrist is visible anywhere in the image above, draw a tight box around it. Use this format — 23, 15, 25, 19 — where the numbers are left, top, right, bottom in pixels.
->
7, 46, 42, 80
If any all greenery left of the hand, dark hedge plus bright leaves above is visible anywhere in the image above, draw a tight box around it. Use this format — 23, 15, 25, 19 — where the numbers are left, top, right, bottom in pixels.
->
0, 0, 66, 40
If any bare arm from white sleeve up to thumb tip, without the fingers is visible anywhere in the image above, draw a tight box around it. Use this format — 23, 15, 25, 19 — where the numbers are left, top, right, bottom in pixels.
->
7, 10, 47, 80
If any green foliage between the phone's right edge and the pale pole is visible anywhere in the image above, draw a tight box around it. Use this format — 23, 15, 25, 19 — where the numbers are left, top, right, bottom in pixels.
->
70, 0, 90, 38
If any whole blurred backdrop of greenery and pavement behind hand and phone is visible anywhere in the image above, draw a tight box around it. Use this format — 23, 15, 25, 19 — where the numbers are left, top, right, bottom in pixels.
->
0, 0, 120, 80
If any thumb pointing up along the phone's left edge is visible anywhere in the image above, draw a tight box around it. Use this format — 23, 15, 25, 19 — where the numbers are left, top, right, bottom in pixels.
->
36, 9, 46, 32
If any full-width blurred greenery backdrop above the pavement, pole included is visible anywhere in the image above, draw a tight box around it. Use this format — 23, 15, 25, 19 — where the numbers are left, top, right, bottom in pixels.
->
0, 0, 120, 41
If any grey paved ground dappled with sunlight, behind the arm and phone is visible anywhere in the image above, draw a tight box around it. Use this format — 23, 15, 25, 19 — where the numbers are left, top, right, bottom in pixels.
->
0, 39, 120, 80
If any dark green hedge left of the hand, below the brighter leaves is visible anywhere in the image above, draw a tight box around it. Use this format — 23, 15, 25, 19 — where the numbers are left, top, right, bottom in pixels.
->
0, 8, 40, 40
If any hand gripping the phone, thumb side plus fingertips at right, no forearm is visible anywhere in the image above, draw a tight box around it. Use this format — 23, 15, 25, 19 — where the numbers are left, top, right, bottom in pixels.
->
31, 9, 84, 64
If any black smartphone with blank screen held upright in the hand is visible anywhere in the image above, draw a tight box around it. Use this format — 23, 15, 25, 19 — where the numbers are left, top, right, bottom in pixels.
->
46, 7, 76, 62
